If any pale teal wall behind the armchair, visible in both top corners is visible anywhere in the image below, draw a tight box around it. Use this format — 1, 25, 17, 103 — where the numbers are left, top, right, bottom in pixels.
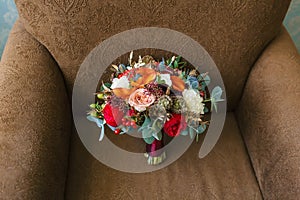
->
0, 0, 300, 59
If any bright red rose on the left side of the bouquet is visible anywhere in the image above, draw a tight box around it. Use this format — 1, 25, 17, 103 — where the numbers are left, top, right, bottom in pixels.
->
102, 104, 124, 127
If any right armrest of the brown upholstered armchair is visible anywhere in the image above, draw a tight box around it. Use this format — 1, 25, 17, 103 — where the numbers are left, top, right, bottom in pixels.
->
237, 29, 300, 200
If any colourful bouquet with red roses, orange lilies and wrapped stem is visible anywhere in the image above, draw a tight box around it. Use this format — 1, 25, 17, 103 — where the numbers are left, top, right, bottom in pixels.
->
87, 52, 222, 165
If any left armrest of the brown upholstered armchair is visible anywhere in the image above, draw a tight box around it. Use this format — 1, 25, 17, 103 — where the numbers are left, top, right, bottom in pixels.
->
0, 19, 71, 200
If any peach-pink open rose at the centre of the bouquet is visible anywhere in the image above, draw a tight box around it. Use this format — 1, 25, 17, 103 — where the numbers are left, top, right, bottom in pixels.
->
128, 89, 155, 112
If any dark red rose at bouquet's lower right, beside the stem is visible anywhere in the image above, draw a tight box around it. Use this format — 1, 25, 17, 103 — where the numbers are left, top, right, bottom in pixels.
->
164, 114, 187, 137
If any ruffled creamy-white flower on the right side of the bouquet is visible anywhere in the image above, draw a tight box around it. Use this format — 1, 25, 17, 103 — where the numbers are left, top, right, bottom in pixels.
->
182, 89, 204, 114
